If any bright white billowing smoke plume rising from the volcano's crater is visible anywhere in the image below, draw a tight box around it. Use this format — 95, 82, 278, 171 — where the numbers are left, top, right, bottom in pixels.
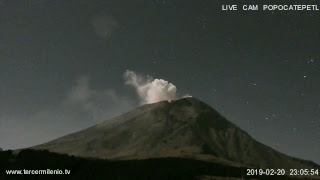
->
124, 70, 177, 104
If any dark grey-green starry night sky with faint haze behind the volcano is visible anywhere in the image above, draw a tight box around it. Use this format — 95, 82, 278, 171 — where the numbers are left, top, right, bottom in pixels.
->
0, 0, 320, 163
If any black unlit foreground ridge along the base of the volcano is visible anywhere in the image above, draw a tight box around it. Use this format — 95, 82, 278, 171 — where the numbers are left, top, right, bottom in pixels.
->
0, 150, 308, 180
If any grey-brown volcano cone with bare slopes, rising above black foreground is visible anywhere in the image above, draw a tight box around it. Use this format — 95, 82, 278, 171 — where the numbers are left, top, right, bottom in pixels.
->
31, 97, 319, 169
